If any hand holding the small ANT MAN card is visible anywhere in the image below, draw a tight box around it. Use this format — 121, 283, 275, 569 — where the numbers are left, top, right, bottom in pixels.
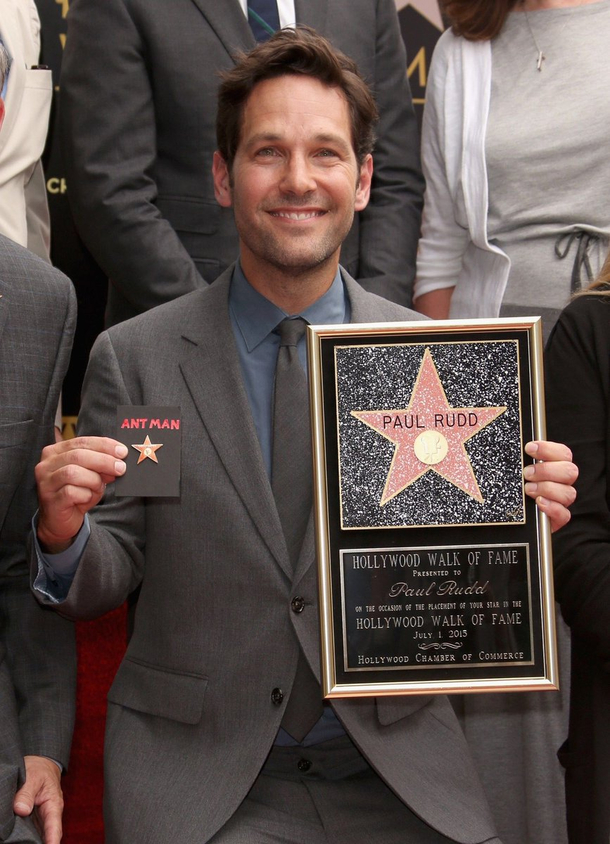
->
36, 437, 127, 554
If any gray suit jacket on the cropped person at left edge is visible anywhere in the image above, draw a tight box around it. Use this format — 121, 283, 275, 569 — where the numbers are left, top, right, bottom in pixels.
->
0, 236, 76, 840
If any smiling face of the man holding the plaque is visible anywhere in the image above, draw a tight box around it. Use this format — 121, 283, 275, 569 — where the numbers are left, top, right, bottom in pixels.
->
214, 76, 372, 283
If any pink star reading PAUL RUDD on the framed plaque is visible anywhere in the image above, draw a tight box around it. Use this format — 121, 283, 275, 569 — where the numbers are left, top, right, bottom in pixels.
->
352, 349, 506, 507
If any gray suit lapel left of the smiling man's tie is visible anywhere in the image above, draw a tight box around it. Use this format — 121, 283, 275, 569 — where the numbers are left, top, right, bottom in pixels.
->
180, 269, 292, 578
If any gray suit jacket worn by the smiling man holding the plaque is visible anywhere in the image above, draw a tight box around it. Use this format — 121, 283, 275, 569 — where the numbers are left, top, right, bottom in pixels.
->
33, 272, 494, 844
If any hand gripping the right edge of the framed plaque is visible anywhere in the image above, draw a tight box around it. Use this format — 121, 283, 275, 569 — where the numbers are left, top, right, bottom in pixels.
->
523, 440, 578, 532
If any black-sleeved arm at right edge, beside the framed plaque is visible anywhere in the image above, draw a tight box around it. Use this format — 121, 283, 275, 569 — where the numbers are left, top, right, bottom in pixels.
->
545, 297, 610, 666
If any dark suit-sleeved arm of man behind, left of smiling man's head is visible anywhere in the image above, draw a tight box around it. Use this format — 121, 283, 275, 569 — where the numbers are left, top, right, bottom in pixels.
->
60, 0, 207, 311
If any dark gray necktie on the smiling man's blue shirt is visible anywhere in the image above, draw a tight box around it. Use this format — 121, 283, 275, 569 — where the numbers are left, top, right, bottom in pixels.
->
271, 317, 322, 741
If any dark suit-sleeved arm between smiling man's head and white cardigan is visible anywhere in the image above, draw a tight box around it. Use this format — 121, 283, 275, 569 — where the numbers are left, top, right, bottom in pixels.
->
358, 0, 424, 306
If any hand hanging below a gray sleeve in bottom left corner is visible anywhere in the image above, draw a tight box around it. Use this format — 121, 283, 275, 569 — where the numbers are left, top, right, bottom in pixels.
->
13, 756, 64, 844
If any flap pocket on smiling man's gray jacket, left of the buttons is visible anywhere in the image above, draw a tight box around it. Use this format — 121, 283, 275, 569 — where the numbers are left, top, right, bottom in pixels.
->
108, 657, 208, 724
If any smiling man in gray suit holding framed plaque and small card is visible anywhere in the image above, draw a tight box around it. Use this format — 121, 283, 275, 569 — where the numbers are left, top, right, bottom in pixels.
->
34, 30, 575, 844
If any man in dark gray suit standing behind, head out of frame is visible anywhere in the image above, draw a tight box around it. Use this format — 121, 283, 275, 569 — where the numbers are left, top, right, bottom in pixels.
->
60, 0, 423, 325
